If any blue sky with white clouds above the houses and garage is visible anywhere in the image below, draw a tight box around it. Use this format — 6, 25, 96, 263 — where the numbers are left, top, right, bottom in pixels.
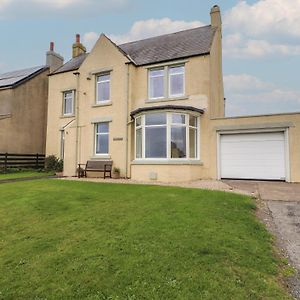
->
0, 0, 300, 116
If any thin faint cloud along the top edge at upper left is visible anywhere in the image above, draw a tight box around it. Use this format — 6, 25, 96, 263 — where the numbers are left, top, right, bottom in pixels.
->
0, 0, 129, 19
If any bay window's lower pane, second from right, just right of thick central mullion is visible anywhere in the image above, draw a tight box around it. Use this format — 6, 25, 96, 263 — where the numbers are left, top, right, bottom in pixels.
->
171, 126, 186, 158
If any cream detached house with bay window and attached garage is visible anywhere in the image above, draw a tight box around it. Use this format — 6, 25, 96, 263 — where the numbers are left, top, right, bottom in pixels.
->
46, 6, 300, 182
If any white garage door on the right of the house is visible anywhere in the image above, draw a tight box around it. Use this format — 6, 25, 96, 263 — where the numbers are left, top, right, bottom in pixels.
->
219, 132, 286, 180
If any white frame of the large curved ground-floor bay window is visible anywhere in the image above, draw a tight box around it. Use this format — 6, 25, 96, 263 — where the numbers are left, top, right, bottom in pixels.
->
134, 111, 200, 162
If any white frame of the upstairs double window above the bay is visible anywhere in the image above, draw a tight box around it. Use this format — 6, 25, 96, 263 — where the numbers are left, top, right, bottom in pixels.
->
148, 63, 186, 101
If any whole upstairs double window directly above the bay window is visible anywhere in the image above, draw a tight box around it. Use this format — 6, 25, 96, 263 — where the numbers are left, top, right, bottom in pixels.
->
148, 65, 185, 100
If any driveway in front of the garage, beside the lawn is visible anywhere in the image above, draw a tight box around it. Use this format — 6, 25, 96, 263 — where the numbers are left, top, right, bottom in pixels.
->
223, 180, 300, 270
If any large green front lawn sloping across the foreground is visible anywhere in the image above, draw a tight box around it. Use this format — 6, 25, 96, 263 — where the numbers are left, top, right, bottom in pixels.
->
0, 180, 290, 300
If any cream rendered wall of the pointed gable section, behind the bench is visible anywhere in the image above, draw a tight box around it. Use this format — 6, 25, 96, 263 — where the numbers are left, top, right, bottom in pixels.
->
73, 35, 128, 176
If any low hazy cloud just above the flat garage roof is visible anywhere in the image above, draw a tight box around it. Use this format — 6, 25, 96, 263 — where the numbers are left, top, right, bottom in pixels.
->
224, 74, 300, 116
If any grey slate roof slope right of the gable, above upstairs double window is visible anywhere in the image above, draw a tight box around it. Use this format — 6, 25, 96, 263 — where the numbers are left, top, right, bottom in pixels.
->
119, 25, 216, 66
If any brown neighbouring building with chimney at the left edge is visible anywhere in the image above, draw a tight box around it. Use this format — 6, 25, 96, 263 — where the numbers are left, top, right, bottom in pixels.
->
0, 43, 63, 154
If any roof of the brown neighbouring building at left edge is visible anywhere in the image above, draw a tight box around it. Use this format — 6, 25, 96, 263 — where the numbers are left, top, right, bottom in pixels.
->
0, 66, 48, 88
